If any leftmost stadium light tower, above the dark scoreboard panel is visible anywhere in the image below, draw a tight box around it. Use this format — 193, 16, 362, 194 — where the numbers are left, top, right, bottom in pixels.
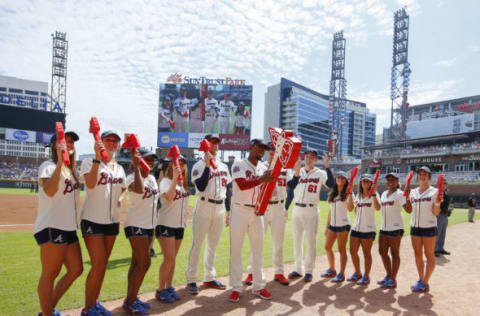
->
50, 31, 68, 113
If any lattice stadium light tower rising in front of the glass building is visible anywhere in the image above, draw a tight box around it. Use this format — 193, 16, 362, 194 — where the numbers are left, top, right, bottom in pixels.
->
328, 31, 347, 160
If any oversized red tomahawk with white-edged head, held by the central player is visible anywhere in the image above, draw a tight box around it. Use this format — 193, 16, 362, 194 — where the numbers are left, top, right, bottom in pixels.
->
255, 128, 302, 216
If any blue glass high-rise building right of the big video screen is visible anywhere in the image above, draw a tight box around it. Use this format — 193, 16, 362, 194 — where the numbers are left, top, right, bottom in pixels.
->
264, 78, 376, 158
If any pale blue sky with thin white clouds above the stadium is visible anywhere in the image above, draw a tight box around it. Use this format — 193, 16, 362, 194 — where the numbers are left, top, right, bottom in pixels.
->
0, 0, 480, 153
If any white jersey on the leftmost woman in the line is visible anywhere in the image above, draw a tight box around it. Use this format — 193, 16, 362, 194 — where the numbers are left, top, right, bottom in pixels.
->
34, 160, 80, 233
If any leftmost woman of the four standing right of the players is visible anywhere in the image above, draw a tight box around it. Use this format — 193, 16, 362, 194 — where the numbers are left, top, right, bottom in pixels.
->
321, 171, 354, 283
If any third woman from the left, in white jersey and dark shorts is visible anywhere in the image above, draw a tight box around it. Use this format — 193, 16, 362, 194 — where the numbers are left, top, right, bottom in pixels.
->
123, 148, 159, 315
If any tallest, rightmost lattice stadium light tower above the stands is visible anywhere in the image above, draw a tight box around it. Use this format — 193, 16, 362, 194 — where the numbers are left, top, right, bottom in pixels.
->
388, 8, 412, 142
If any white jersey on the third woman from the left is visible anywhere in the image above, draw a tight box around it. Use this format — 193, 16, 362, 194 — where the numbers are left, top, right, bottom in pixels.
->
123, 173, 159, 229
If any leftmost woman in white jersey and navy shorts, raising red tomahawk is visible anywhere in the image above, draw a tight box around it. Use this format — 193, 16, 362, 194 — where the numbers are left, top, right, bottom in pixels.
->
34, 132, 83, 316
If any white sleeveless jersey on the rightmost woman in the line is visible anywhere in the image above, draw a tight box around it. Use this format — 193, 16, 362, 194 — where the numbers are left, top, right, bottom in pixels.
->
410, 186, 438, 228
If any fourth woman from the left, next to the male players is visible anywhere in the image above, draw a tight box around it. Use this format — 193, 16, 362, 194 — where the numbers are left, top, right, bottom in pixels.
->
155, 156, 189, 303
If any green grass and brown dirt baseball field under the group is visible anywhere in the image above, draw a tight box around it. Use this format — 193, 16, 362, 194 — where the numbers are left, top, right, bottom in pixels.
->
0, 189, 480, 315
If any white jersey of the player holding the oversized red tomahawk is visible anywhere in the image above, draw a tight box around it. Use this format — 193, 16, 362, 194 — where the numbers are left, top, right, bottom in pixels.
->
232, 158, 267, 205
